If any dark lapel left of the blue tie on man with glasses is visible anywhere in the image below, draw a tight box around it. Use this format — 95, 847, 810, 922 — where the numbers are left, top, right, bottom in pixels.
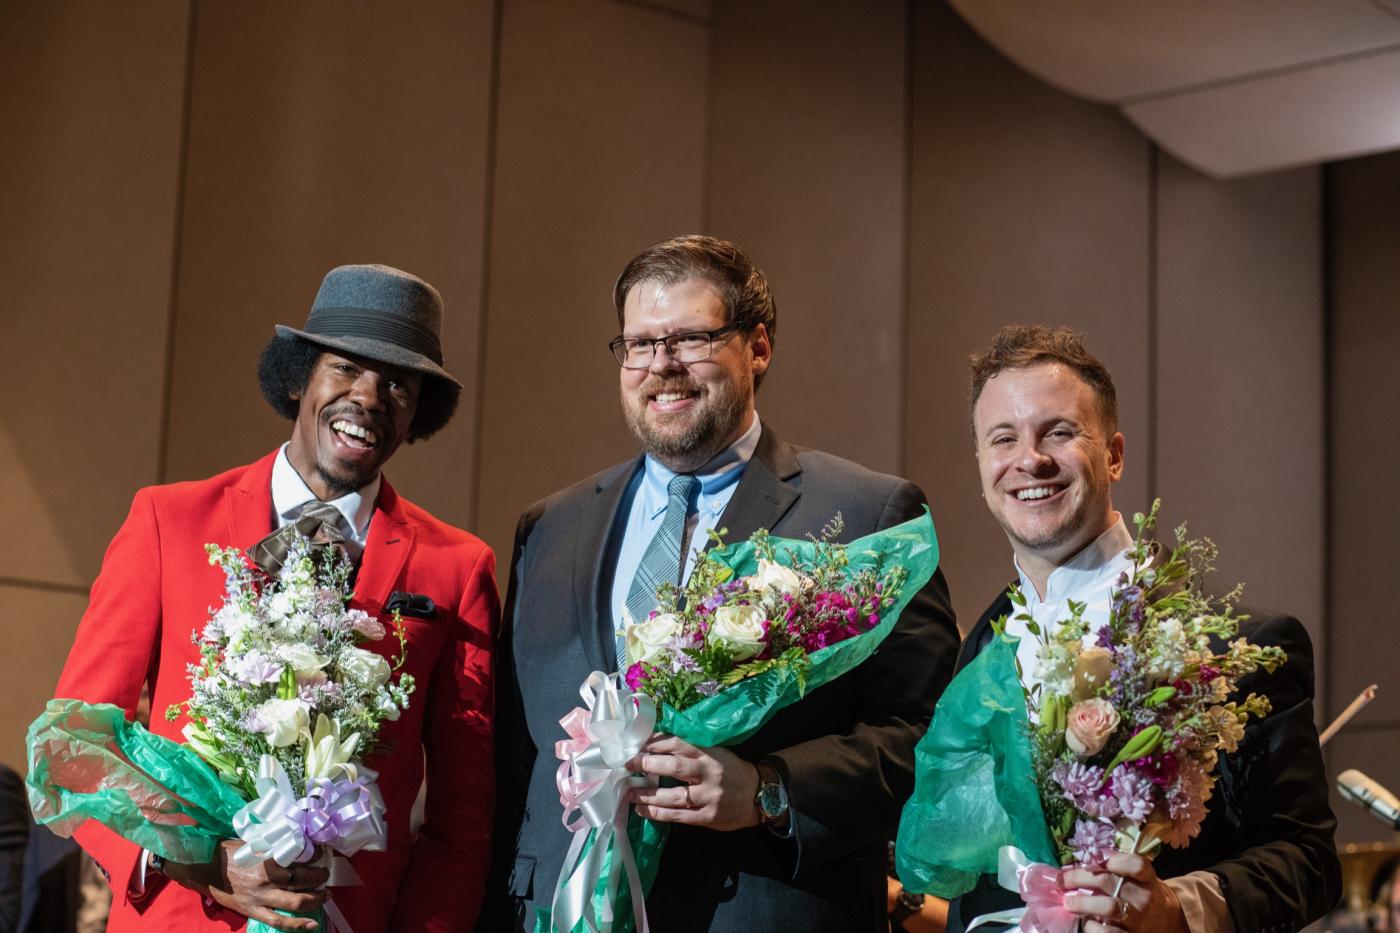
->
574, 457, 643, 672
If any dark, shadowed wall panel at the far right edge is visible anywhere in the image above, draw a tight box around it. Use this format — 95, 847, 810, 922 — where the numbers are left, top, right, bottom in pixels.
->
1327, 153, 1400, 734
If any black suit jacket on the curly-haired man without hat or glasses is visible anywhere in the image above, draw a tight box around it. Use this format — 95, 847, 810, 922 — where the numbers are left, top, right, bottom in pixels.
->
948, 593, 1341, 933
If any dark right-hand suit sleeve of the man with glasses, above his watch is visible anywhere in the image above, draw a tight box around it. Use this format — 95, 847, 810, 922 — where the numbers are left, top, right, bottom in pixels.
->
766, 482, 958, 876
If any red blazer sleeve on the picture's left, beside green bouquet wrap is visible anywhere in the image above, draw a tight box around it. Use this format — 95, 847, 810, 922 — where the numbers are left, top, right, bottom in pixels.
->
55, 489, 161, 901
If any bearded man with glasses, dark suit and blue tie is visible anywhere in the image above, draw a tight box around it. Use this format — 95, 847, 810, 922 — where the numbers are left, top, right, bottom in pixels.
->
482, 237, 958, 933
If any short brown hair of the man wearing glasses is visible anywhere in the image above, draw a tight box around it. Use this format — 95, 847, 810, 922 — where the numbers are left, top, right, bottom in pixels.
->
613, 235, 778, 388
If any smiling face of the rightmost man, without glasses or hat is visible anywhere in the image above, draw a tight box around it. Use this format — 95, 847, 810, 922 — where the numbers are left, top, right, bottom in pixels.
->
973, 363, 1123, 588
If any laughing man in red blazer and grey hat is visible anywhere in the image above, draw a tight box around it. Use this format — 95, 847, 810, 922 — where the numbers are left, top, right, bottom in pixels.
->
56, 266, 498, 933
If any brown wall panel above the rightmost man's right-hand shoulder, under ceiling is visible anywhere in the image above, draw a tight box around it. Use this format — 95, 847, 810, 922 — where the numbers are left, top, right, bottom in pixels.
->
1156, 156, 1326, 688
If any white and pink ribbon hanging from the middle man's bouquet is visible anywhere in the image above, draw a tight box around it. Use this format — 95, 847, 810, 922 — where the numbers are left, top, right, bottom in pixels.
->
550, 671, 657, 933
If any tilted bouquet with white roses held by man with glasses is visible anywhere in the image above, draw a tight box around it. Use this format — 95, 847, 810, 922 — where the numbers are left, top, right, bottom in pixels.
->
536, 513, 938, 933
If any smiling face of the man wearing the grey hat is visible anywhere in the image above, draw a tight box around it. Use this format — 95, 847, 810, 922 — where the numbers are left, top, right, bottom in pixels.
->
287, 352, 423, 500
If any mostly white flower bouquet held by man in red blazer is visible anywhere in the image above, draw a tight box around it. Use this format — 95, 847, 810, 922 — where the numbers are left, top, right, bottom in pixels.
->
29, 534, 413, 930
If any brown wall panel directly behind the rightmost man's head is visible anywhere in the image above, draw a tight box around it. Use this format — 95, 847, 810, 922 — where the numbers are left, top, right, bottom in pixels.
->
904, 4, 1149, 629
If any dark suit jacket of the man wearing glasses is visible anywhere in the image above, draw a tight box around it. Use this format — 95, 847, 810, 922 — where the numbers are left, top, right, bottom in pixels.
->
479, 427, 958, 933
